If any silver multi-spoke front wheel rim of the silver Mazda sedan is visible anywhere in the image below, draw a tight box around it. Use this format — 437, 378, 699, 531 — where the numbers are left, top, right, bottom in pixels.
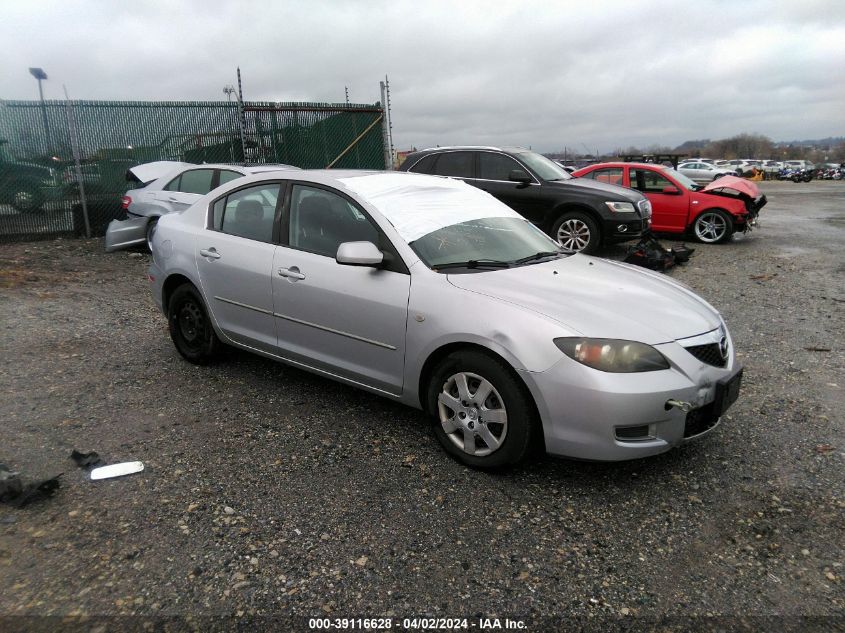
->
437, 372, 508, 457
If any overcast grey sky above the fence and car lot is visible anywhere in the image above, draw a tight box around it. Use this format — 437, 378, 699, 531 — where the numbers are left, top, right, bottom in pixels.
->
0, 0, 845, 152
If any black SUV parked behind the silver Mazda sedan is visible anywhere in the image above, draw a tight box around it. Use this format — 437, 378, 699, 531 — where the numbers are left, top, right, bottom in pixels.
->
399, 147, 651, 253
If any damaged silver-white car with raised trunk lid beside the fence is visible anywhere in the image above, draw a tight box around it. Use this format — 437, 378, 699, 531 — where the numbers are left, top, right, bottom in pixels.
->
106, 160, 297, 253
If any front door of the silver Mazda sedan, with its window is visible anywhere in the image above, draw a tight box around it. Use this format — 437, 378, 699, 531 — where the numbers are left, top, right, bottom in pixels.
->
272, 183, 411, 394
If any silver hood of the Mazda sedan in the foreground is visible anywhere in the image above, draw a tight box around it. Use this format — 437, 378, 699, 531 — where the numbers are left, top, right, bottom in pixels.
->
448, 255, 721, 345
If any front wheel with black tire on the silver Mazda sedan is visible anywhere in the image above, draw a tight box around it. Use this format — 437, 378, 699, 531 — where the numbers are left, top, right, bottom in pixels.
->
426, 350, 541, 469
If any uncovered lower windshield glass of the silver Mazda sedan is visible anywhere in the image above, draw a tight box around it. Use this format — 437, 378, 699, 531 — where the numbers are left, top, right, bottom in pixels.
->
410, 217, 563, 270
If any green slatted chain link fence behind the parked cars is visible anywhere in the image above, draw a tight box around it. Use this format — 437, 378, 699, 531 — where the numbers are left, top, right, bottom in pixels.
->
0, 101, 385, 242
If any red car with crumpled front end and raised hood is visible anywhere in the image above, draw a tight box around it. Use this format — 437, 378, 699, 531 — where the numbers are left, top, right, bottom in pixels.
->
572, 163, 766, 244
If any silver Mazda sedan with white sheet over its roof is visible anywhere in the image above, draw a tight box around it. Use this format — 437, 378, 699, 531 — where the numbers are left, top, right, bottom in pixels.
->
149, 171, 742, 467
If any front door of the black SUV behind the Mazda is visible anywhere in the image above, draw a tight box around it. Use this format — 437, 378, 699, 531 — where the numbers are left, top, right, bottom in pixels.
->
468, 151, 550, 224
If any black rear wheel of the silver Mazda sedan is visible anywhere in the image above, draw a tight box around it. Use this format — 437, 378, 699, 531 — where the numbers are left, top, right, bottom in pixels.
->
167, 284, 222, 365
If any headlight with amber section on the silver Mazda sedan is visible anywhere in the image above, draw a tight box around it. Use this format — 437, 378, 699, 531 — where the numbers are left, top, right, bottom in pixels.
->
555, 338, 669, 374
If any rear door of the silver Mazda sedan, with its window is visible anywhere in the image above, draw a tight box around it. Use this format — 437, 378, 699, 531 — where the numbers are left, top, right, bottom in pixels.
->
195, 182, 283, 352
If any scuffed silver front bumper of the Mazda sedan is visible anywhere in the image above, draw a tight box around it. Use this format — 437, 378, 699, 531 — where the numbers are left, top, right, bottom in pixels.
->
520, 342, 742, 461
